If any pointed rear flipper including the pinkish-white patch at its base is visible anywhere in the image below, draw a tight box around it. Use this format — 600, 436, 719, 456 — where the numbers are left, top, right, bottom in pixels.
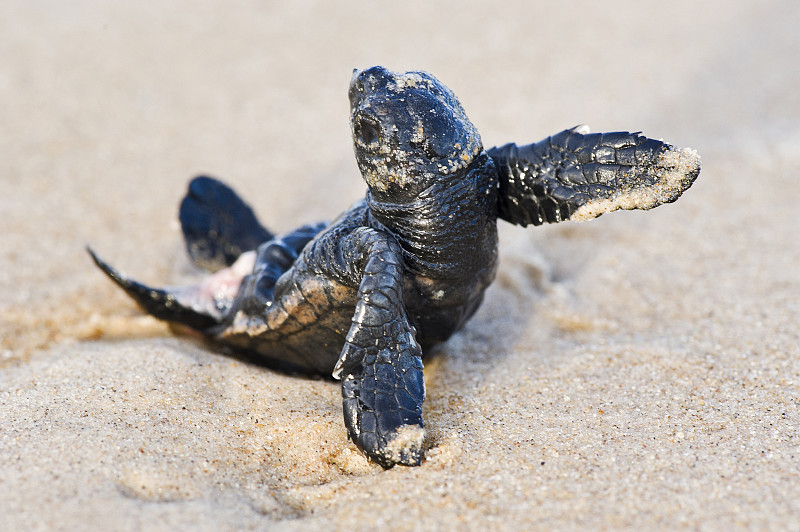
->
86, 248, 248, 333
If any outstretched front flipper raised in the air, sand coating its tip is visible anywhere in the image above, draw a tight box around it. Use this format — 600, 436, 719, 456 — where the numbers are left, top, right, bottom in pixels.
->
487, 126, 700, 226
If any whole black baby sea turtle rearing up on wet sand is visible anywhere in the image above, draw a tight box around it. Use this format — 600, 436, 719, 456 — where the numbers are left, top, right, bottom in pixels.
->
90, 67, 700, 468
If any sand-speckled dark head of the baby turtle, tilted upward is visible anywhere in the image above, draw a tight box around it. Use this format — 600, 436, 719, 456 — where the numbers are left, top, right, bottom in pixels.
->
350, 66, 483, 203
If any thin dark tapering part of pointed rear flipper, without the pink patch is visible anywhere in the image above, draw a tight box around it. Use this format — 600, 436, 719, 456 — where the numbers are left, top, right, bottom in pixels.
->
86, 246, 220, 331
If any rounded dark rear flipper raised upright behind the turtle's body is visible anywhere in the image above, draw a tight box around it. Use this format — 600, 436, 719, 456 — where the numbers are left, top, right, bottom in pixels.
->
179, 176, 273, 272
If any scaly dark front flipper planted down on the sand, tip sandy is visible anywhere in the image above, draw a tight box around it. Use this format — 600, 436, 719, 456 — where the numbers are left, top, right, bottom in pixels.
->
333, 229, 425, 468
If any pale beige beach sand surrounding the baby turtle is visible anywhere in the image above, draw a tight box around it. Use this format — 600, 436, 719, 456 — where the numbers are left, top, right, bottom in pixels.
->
0, 0, 800, 531
